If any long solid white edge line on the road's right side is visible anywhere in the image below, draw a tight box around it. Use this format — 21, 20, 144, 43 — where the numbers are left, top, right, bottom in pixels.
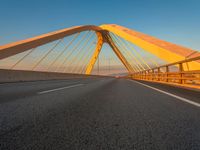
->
130, 80, 200, 107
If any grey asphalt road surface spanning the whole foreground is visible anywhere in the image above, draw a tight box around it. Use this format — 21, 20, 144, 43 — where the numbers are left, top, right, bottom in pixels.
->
0, 78, 200, 150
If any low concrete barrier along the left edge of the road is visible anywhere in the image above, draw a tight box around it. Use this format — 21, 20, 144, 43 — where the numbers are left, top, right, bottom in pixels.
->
0, 69, 100, 83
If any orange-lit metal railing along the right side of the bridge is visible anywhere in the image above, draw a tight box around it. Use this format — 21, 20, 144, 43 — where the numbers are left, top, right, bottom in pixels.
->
130, 56, 200, 89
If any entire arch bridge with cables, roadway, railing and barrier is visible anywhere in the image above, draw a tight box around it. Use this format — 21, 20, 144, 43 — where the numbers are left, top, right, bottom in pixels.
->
0, 24, 200, 149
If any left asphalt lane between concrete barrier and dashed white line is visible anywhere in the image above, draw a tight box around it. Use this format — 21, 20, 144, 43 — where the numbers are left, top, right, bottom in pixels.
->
0, 77, 105, 103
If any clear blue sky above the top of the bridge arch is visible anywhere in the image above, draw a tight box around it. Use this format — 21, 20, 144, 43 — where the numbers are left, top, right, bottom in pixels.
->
0, 0, 200, 50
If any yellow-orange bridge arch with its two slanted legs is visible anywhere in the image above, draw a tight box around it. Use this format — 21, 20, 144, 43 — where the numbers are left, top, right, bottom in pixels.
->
0, 24, 200, 74
